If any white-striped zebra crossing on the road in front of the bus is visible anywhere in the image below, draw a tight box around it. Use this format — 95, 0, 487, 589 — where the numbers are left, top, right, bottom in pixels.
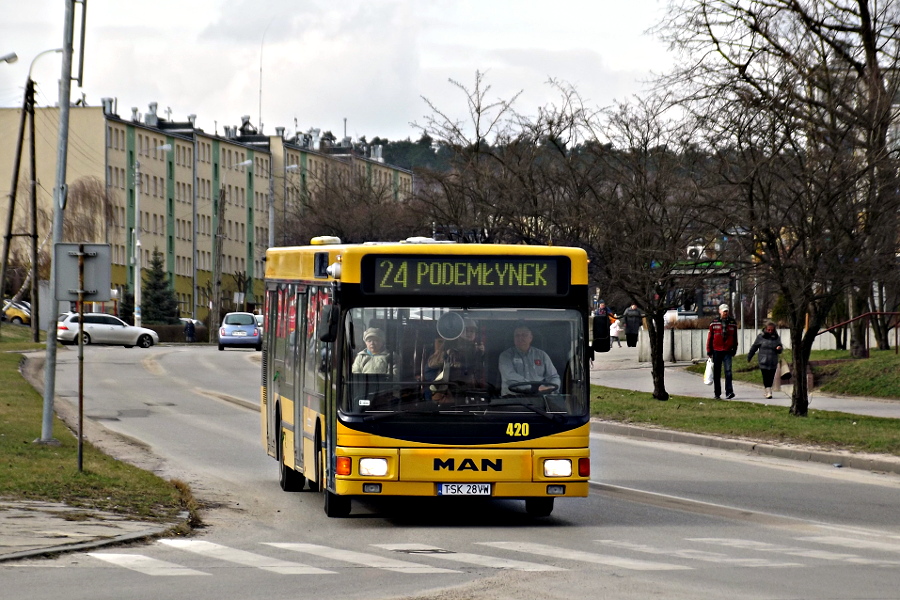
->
81, 535, 900, 577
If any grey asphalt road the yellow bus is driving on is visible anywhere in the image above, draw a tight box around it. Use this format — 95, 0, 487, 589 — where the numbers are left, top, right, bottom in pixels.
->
0, 346, 900, 600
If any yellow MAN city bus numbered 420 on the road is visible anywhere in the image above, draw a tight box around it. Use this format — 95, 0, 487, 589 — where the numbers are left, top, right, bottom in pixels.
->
261, 238, 590, 517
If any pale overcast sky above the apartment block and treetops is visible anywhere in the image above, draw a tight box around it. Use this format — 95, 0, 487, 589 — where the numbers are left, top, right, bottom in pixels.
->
0, 0, 671, 140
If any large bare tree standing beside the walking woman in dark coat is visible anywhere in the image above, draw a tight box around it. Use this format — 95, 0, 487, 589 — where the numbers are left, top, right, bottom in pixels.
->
662, 0, 900, 416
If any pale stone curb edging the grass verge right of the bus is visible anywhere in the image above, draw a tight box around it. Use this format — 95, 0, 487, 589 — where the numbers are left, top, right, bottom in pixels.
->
591, 419, 900, 474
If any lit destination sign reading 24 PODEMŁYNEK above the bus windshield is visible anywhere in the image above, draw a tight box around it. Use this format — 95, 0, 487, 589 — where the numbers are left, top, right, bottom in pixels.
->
362, 255, 570, 296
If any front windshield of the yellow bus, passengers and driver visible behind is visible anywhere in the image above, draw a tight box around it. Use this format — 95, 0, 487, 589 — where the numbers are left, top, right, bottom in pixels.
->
341, 306, 588, 420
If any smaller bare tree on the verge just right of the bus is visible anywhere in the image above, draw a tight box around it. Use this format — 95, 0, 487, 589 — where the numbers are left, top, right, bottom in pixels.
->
580, 96, 718, 400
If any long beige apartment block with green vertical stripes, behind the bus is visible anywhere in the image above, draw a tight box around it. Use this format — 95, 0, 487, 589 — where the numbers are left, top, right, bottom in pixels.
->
0, 99, 412, 319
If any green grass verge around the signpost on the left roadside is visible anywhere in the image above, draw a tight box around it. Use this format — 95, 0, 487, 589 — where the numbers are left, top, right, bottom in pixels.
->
0, 325, 197, 523
